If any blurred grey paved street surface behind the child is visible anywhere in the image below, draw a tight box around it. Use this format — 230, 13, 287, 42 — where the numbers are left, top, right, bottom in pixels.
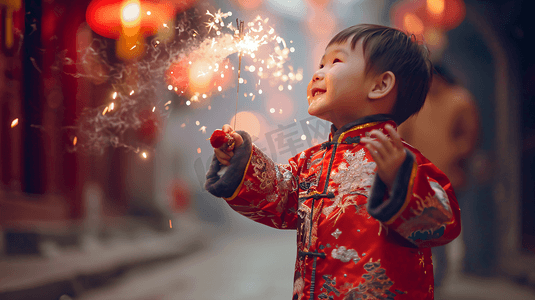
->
77, 217, 535, 300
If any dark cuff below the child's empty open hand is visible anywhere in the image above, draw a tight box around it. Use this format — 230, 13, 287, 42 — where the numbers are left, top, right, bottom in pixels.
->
368, 149, 414, 222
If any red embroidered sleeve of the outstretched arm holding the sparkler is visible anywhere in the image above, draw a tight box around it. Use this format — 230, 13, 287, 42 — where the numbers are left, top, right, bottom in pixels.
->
205, 131, 299, 229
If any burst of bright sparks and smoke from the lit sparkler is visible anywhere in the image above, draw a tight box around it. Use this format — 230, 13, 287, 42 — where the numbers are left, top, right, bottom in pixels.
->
30, 5, 302, 158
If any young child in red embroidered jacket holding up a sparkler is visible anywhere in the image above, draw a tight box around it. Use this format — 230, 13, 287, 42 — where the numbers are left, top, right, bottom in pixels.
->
205, 25, 461, 300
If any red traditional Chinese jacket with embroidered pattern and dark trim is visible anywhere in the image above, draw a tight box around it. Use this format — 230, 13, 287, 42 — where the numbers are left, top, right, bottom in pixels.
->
205, 115, 461, 300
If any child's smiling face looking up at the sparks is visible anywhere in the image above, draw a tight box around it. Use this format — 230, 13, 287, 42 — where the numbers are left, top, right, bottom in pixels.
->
307, 41, 372, 128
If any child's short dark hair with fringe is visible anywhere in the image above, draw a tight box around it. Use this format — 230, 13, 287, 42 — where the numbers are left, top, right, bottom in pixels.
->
328, 24, 433, 125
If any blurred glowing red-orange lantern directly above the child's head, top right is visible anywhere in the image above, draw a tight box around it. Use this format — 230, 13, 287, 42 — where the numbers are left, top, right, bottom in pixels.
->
391, 0, 466, 33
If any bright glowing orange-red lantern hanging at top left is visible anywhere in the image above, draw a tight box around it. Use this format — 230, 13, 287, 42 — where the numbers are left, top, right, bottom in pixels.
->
86, 0, 175, 59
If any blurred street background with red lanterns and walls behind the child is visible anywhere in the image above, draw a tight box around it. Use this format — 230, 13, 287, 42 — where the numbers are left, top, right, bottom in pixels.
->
0, 0, 535, 300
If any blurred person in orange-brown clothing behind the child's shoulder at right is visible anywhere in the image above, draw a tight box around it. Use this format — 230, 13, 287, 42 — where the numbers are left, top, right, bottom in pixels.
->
398, 64, 479, 288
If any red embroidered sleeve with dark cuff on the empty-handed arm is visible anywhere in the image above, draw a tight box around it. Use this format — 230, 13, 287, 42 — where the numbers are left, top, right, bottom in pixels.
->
368, 144, 461, 247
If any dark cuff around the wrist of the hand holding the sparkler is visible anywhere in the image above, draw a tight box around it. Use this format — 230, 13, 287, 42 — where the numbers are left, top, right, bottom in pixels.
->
204, 131, 253, 198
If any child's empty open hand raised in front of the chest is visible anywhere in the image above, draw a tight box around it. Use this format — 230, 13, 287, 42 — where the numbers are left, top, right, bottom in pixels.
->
360, 125, 407, 190
